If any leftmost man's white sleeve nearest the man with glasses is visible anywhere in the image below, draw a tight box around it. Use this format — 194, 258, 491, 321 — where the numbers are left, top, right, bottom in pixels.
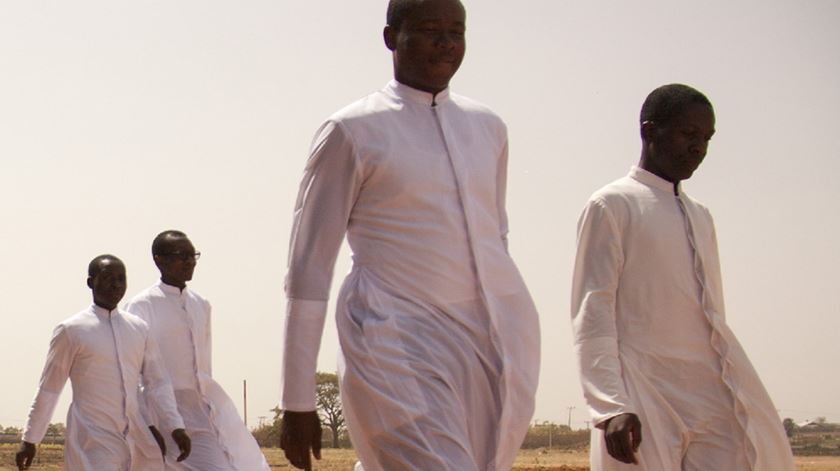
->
140, 334, 184, 433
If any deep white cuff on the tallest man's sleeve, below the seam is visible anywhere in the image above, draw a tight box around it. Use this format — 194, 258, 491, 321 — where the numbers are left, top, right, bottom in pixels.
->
280, 299, 327, 412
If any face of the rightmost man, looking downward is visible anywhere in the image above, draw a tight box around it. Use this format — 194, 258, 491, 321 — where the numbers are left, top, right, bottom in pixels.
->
645, 103, 715, 183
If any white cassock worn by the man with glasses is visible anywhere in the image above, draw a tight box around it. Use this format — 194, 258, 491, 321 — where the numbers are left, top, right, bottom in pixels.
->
126, 281, 269, 471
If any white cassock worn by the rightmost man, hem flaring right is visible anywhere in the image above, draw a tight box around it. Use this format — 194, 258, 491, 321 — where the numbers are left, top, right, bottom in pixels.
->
572, 167, 794, 471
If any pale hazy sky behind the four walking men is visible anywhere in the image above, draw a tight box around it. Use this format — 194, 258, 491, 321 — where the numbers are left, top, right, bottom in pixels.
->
0, 0, 840, 427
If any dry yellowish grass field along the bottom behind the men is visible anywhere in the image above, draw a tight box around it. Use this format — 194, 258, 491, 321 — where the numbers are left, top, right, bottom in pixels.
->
0, 445, 840, 471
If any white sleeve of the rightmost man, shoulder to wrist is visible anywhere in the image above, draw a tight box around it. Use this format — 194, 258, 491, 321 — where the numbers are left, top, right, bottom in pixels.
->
572, 200, 635, 426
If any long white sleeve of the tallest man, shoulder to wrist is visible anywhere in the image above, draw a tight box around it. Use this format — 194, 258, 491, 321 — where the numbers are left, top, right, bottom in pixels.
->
280, 121, 362, 411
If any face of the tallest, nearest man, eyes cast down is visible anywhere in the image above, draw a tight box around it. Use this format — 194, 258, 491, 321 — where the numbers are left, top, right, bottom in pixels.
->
385, 0, 466, 93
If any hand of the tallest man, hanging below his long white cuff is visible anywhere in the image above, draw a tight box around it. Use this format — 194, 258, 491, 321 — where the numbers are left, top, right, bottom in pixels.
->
280, 410, 321, 471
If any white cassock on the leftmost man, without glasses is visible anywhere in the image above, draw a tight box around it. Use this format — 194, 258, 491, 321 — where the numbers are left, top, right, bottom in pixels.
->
23, 305, 184, 471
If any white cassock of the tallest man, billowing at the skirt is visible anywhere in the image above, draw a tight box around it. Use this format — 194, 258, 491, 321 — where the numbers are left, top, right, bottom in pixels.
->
281, 81, 540, 471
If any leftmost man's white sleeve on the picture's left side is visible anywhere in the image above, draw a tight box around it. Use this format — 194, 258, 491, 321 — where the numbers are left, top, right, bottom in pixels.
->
23, 325, 76, 443
